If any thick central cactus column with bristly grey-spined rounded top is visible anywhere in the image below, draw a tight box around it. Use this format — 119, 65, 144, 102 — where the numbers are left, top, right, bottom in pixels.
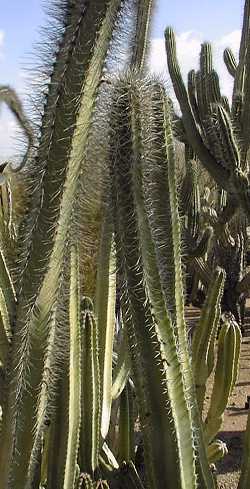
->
110, 76, 216, 488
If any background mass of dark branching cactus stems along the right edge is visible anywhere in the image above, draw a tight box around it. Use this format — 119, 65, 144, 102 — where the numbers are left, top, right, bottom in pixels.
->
169, 1, 250, 324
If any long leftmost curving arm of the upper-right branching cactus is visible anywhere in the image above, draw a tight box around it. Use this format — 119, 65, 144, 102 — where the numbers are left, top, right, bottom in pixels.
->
165, 28, 227, 190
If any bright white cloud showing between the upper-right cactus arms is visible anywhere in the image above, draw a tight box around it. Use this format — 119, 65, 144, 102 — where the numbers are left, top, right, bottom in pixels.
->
150, 30, 241, 102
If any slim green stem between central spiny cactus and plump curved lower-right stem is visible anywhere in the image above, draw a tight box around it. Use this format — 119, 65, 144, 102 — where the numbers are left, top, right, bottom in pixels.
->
192, 270, 225, 413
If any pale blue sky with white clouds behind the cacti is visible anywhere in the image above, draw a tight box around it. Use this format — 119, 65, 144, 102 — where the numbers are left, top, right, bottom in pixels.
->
0, 0, 244, 161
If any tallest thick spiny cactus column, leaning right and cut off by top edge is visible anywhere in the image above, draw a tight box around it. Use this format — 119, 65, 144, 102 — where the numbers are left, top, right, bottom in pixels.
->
0, 0, 127, 489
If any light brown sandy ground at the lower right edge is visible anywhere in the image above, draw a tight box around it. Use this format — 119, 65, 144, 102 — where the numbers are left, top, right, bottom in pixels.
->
186, 299, 250, 489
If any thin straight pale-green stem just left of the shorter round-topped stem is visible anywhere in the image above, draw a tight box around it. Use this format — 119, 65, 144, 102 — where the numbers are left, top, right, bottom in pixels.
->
63, 247, 81, 489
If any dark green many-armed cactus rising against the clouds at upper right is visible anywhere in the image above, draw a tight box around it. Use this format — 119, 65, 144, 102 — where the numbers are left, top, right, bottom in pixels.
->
165, 0, 250, 215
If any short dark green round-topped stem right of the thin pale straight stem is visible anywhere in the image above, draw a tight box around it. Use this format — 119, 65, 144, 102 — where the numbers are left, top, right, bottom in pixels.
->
79, 297, 101, 474
